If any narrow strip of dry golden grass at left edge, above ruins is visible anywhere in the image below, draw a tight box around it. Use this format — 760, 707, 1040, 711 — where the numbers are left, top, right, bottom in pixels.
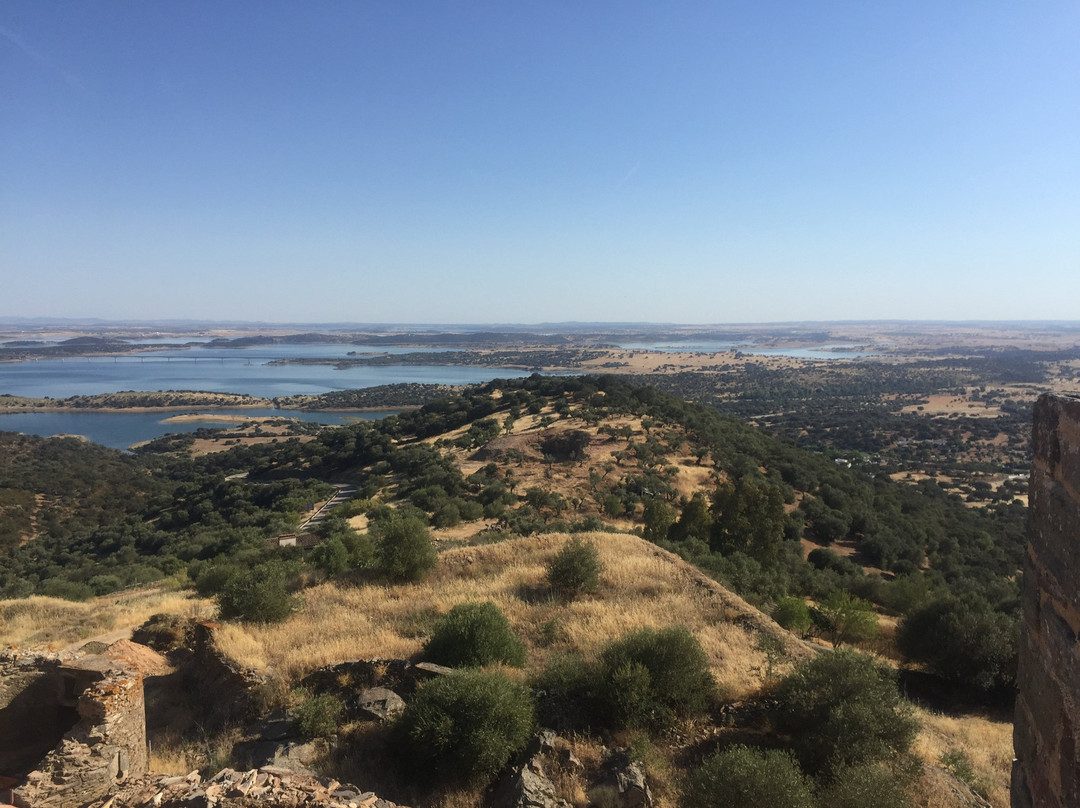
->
0, 588, 214, 650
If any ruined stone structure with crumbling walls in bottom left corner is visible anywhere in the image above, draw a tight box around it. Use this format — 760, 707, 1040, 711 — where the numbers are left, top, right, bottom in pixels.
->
0, 651, 147, 808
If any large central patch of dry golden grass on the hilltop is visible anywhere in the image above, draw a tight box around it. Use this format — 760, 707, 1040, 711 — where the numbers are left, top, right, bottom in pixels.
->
217, 534, 794, 697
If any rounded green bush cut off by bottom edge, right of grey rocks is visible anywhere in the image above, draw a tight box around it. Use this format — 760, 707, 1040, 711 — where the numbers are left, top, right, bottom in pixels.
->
681, 746, 812, 808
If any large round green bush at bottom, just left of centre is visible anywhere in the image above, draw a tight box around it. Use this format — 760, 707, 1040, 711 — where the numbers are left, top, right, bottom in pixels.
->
396, 671, 535, 783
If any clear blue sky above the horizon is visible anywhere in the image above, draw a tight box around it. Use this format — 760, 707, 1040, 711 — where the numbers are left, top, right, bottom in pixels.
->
0, 0, 1080, 323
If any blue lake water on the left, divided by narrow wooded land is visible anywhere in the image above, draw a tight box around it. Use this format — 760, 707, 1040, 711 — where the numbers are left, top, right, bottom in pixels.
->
0, 344, 529, 448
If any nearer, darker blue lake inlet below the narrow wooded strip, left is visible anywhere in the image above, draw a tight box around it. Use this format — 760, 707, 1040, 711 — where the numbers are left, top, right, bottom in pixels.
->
0, 409, 397, 449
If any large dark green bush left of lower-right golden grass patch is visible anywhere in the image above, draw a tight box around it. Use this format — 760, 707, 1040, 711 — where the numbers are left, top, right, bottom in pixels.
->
772, 650, 918, 775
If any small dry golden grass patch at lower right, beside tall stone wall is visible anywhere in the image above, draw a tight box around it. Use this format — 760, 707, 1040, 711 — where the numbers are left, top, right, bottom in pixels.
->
914, 710, 1013, 808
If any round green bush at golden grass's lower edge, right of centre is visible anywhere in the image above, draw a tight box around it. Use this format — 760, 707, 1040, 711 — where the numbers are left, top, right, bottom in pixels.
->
600, 627, 715, 726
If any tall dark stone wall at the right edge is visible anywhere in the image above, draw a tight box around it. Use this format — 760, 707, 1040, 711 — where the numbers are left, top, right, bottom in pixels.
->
1012, 395, 1080, 808
